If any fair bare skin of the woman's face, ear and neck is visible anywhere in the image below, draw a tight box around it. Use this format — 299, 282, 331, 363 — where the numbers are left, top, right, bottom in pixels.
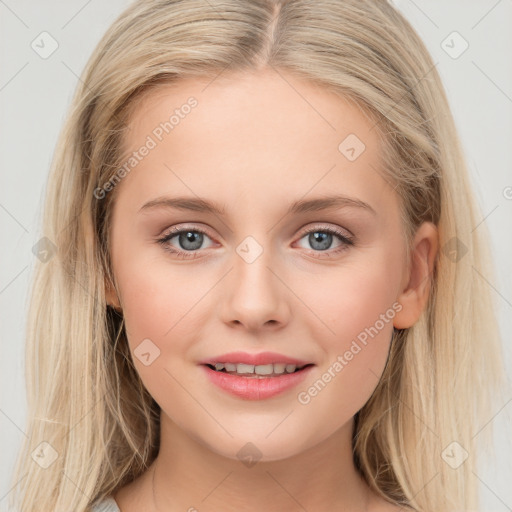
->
106, 70, 438, 512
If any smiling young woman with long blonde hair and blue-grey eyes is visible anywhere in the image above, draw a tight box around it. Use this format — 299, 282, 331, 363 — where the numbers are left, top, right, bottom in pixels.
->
13, 0, 503, 512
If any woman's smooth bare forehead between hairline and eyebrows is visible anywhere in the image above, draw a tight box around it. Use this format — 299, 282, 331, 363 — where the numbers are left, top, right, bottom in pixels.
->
114, 70, 390, 218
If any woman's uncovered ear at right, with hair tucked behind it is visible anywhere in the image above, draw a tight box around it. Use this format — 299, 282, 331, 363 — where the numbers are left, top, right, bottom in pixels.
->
393, 222, 439, 329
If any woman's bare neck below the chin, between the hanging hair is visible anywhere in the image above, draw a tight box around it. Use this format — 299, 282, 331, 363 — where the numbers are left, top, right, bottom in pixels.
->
148, 412, 370, 512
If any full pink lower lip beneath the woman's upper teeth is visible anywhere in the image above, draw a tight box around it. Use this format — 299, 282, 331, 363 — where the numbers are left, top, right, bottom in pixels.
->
202, 365, 313, 400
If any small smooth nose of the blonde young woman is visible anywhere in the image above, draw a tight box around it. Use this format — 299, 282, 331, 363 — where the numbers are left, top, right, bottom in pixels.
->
221, 244, 291, 332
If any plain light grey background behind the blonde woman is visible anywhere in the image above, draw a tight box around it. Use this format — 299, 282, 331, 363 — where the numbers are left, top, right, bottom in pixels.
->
0, 0, 512, 512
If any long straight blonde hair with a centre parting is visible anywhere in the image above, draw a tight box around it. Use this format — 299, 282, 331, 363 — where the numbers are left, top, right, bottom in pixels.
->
11, 0, 505, 512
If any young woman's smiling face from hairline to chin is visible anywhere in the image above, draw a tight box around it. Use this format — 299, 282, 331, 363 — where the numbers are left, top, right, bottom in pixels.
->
107, 67, 430, 460
